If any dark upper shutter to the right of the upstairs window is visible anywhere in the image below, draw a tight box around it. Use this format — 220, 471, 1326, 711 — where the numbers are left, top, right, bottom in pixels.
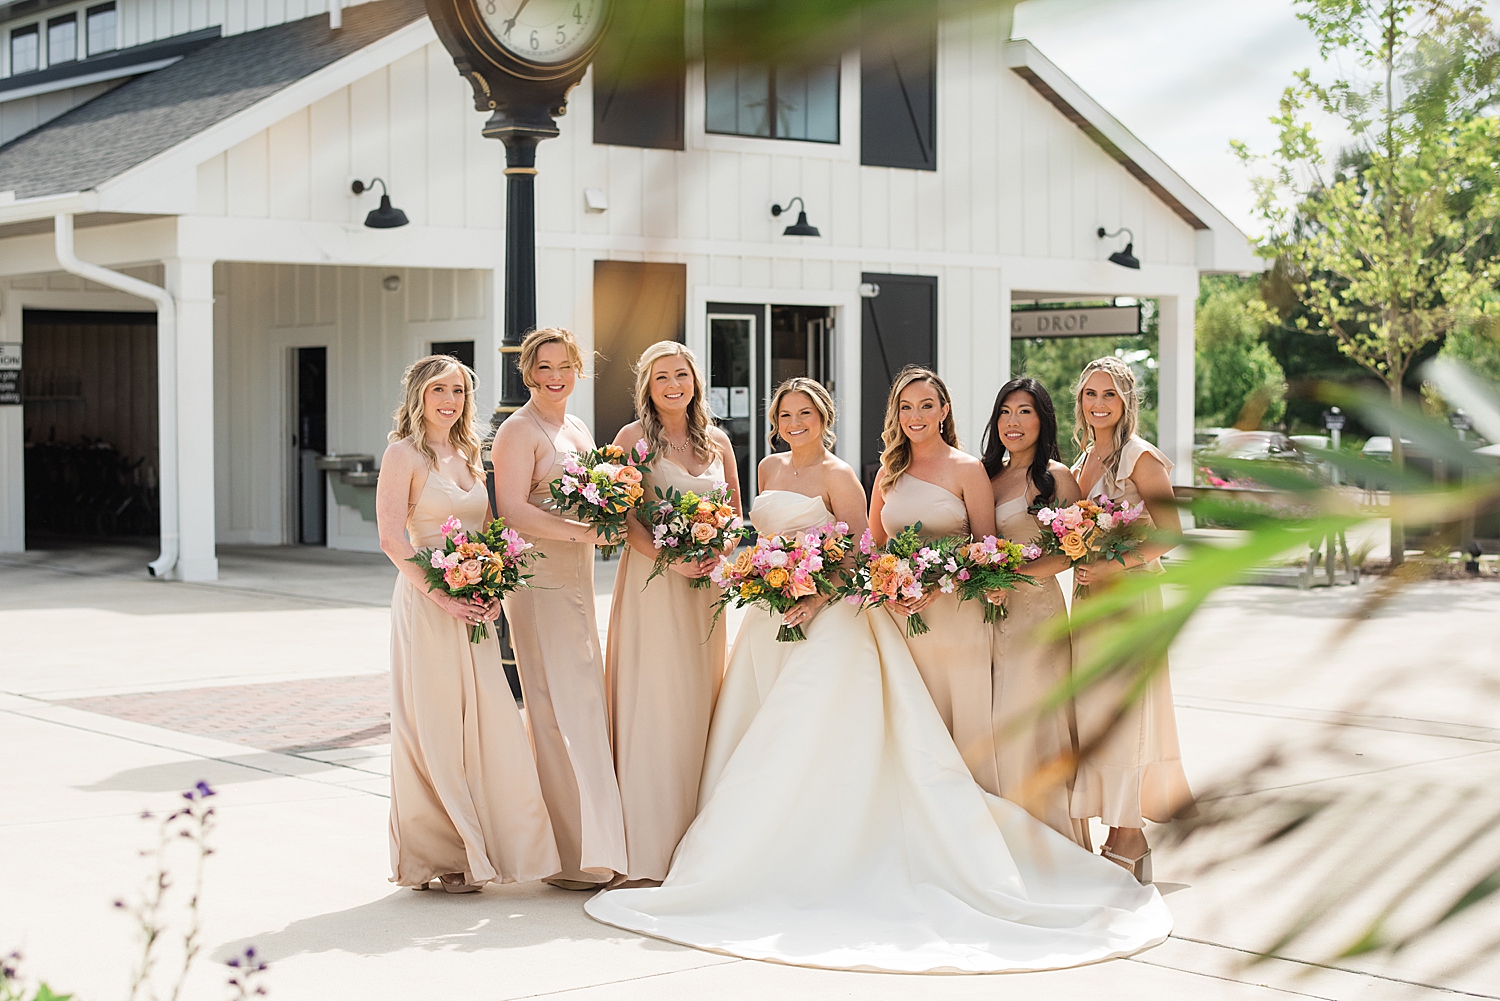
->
860, 16, 938, 170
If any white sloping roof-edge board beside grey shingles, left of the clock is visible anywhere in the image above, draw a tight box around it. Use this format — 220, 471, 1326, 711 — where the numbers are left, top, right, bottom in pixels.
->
99, 17, 438, 213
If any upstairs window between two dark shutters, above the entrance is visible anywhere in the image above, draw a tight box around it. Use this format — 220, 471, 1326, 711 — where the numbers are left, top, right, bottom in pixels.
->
704, 0, 839, 143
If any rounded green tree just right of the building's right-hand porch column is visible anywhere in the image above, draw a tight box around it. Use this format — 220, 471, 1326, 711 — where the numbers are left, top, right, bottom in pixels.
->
1194, 276, 1287, 428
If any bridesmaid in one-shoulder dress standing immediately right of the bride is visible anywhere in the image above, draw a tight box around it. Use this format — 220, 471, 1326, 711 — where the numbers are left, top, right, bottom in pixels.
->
870, 365, 1001, 795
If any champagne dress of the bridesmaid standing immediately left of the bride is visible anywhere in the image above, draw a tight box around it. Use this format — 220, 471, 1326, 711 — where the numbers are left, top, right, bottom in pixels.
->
605, 458, 725, 882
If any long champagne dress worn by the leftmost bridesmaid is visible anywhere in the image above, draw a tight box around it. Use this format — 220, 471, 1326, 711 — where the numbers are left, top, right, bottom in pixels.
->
390, 471, 558, 887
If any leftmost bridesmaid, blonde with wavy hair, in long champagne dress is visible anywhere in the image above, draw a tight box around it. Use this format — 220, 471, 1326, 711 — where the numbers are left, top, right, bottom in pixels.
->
375, 356, 558, 893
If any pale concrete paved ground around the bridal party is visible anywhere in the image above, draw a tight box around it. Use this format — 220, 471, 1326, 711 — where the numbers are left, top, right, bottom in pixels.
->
0, 546, 1500, 1001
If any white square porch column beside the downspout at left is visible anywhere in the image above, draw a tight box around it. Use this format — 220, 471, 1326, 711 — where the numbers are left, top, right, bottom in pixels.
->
165, 258, 219, 581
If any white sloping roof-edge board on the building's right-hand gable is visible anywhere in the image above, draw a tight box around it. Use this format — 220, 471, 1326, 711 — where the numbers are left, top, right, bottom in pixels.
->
1005, 39, 1266, 272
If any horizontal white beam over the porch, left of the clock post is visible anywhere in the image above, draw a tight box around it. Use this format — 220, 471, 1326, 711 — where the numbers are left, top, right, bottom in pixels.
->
177, 216, 506, 269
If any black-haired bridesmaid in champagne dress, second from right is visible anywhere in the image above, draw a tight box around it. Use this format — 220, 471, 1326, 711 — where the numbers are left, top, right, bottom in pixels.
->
984, 378, 1089, 848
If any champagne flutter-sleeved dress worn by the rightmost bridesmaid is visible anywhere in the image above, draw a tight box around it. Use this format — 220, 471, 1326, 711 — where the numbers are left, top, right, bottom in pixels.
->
1071, 438, 1193, 827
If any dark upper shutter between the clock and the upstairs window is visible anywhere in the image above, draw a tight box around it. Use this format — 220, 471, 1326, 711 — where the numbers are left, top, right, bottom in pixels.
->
594, 3, 687, 150
